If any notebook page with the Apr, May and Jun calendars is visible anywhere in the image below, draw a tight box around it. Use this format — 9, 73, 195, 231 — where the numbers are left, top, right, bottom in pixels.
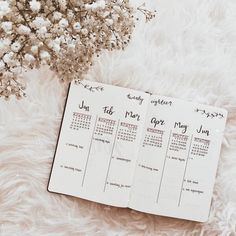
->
129, 95, 227, 222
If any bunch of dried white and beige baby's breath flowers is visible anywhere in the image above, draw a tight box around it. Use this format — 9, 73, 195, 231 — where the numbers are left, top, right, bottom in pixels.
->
0, 0, 156, 98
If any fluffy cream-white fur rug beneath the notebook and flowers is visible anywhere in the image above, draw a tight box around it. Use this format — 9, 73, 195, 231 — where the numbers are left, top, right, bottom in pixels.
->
0, 0, 236, 236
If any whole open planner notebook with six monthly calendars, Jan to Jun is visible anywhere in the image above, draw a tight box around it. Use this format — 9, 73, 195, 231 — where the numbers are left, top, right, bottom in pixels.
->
48, 80, 227, 222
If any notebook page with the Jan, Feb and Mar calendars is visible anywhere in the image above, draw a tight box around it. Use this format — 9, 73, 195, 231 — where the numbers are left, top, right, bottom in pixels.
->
48, 80, 150, 206
